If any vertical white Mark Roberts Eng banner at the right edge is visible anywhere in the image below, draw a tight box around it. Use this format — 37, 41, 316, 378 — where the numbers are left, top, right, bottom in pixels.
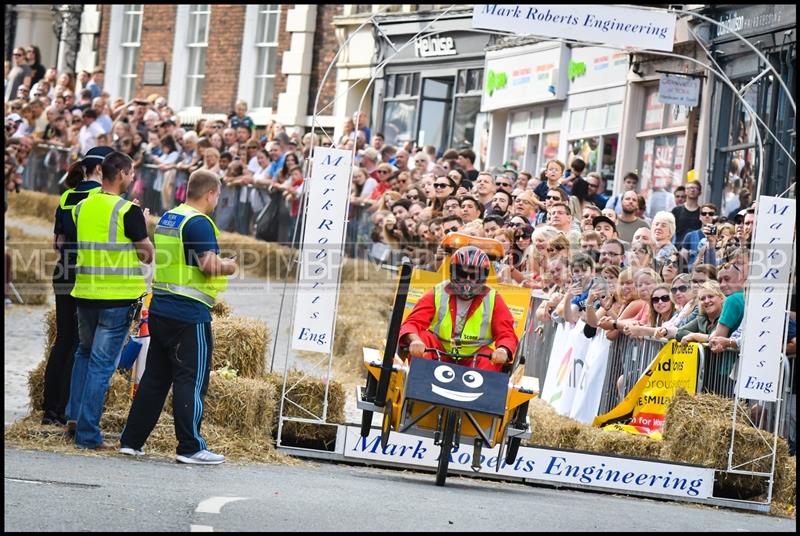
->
736, 196, 797, 401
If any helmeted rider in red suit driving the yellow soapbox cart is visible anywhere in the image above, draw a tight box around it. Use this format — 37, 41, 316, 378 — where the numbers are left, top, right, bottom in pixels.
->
399, 246, 518, 371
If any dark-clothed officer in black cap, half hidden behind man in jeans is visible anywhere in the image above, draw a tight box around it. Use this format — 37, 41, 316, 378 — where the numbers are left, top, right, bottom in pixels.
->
42, 147, 114, 426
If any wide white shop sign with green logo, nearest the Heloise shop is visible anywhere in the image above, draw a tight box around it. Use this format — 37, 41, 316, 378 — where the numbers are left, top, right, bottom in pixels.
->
481, 44, 569, 112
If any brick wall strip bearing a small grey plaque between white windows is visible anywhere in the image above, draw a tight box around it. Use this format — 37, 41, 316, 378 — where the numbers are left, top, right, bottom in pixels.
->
134, 4, 178, 97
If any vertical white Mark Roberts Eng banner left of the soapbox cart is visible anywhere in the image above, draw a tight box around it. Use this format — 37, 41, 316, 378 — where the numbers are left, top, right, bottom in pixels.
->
292, 147, 352, 353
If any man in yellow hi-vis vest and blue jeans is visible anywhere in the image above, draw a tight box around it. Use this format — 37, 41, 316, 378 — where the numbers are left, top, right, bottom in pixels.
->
67, 151, 153, 449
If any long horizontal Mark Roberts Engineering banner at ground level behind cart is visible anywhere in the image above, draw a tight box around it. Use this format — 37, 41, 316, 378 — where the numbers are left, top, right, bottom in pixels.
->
343, 426, 714, 499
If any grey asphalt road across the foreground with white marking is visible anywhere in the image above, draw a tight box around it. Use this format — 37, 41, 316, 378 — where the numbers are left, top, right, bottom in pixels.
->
4, 449, 796, 532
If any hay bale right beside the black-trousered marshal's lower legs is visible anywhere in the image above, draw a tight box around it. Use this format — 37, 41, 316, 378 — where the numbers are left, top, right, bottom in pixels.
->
203, 372, 278, 437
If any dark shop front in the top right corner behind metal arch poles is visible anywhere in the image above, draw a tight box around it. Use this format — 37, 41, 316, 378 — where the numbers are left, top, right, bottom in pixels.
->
704, 4, 797, 203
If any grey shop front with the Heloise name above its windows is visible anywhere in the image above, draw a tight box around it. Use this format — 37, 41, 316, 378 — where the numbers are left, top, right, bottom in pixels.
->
373, 11, 490, 155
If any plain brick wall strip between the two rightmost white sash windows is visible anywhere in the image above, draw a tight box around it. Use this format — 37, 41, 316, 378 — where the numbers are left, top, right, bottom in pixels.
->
203, 4, 247, 113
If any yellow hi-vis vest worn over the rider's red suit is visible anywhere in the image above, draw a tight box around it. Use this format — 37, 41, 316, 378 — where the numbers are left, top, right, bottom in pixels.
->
428, 282, 497, 355
